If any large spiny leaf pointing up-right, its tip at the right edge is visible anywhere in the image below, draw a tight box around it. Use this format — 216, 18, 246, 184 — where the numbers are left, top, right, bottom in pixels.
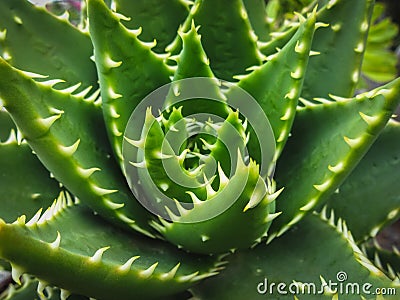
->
271, 79, 400, 236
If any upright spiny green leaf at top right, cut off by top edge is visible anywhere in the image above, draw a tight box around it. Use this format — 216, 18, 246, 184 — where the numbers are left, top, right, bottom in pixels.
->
302, 0, 374, 100
